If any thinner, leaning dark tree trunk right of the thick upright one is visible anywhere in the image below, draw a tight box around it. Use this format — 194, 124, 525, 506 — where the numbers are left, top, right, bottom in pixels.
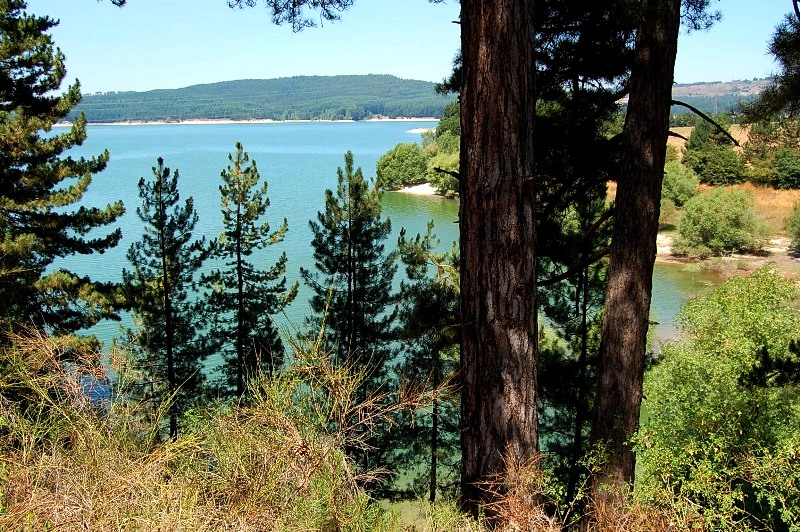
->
591, 0, 681, 510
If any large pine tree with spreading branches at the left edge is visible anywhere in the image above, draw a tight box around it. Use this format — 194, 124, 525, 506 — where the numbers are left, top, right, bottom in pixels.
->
0, 0, 124, 334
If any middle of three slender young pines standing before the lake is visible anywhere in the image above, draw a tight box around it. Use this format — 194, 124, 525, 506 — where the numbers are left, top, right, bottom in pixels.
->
203, 143, 297, 397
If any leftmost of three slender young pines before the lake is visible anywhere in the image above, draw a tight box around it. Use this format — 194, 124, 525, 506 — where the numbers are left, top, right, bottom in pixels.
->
122, 157, 210, 439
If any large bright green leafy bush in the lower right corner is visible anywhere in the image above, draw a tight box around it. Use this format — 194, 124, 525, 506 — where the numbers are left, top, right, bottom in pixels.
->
636, 269, 800, 530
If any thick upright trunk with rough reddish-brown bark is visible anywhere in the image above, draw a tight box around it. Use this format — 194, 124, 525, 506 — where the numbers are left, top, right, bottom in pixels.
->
460, 0, 538, 513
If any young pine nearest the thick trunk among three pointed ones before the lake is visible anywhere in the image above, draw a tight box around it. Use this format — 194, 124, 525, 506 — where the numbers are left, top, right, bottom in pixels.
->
300, 152, 397, 478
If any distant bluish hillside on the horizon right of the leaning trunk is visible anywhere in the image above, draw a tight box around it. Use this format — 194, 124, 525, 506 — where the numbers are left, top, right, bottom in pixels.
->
672, 79, 772, 114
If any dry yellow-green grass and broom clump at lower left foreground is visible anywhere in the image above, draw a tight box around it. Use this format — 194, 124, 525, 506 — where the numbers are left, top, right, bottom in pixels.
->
0, 334, 416, 530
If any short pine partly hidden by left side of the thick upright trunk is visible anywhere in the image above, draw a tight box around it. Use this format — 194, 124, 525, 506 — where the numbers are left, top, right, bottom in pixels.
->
392, 222, 461, 502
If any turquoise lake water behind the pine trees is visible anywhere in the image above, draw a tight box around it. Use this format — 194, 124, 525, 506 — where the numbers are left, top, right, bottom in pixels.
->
56, 120, 718, 350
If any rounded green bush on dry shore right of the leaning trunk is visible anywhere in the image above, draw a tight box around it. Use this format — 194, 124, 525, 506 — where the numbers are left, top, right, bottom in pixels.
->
673, 188, 769, 258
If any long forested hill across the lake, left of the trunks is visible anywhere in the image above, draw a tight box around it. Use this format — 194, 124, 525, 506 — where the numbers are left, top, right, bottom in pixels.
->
73, 74, 455, 122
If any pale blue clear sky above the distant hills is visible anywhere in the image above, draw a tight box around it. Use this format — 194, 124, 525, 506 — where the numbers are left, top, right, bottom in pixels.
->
23, 0, 791, 92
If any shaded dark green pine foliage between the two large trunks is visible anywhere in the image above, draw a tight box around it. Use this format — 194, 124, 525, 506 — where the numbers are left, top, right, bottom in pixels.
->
538, 195, 611, 504
